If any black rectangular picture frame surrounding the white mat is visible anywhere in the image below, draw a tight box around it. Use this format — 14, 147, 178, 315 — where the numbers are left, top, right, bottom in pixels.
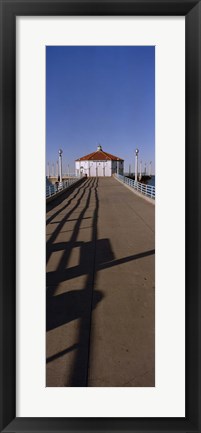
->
0, 0, 201, 433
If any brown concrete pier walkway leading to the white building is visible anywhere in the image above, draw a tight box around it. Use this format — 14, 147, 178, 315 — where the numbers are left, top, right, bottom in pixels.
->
46, 178, 155, 387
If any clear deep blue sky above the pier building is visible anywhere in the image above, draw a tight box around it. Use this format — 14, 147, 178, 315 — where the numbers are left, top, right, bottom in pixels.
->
46, 46, 155, 173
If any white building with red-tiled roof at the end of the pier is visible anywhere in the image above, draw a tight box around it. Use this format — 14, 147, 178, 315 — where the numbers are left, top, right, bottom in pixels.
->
75, 145, 124, 177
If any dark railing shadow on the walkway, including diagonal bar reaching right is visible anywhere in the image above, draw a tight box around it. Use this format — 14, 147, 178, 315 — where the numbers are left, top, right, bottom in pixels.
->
46, 178, 154, 387
